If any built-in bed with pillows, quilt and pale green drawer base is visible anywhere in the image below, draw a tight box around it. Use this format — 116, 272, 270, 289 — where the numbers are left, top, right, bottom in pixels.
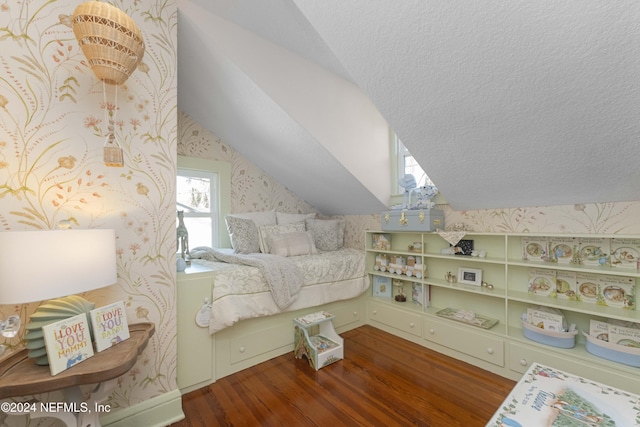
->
177, 211, 369, 393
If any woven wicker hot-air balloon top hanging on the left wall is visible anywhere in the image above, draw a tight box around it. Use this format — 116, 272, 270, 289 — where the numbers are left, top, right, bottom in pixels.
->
73, 1, 144, 85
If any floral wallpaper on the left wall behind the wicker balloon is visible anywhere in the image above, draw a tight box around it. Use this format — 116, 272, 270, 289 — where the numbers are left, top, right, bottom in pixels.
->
0, 0, 177, 425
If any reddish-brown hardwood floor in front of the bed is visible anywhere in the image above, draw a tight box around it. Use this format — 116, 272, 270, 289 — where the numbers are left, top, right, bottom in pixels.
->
172, 326, 515, 427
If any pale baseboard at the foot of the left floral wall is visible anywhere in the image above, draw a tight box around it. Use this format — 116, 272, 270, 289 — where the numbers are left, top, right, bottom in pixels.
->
100, 389, 184, 427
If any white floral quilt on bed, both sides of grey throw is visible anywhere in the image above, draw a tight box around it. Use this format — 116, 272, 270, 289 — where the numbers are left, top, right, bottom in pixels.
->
192, 248, 369, 334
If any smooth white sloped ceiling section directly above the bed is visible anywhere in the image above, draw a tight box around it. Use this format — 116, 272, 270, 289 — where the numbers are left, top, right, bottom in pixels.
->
178, 1, 391, 215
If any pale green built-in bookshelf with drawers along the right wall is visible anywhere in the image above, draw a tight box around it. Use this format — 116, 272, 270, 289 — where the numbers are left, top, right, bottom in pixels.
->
365, 231, 640, 393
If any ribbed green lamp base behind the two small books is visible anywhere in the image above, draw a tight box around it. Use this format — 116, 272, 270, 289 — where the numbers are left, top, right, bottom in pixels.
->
24, 295, 96, 366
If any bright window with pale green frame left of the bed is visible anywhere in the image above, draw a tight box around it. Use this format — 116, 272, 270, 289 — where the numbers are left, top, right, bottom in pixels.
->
176, 156, 231, 248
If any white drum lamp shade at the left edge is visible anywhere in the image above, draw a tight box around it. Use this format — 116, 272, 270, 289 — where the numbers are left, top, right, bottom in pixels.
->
0, 229, 117, 304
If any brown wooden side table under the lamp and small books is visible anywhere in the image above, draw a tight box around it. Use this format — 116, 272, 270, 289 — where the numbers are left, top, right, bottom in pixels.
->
0, 323, 155, 427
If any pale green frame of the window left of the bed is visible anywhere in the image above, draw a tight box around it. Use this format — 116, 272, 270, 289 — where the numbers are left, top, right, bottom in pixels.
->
176, 156, 231, 248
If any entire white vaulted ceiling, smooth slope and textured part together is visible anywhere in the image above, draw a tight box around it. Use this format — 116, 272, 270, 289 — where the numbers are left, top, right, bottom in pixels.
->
178, 0, 640, 214
